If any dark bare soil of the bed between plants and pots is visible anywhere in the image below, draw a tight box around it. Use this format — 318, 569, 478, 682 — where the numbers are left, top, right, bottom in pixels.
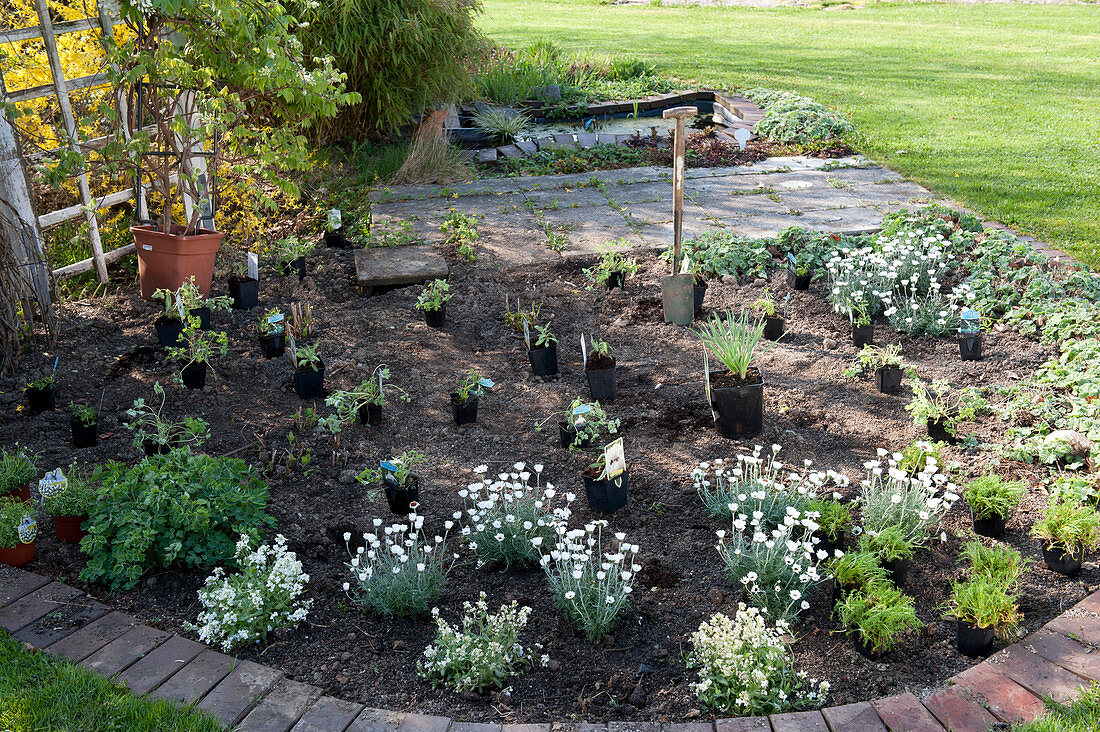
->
0, 231, 1100, 722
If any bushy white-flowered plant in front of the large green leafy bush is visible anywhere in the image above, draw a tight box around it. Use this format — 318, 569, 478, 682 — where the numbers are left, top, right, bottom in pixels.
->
190, 534, 314, 651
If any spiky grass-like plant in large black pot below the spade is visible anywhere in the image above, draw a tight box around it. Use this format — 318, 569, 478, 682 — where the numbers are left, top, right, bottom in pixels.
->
697, 310, 771, 437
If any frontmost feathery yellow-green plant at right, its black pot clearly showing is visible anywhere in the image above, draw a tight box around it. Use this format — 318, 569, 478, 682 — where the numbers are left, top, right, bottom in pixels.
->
947, 577, 1020, 658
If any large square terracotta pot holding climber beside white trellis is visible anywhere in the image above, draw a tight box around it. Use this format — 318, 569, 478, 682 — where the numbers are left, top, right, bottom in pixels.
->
130, 226, 226, 299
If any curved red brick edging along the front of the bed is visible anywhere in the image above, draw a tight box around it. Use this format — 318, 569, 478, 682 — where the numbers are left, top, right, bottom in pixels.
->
0, 565, 1100, 732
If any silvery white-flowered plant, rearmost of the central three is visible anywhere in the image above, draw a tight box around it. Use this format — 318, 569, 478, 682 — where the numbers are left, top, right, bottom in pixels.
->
457, 462, 571, 568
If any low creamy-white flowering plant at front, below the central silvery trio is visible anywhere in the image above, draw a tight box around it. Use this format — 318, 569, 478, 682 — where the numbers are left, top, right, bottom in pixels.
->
417, 592, 549, 691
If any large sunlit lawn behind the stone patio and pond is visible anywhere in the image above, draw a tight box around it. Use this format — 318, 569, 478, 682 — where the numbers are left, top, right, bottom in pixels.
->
481, 0, 1100, 265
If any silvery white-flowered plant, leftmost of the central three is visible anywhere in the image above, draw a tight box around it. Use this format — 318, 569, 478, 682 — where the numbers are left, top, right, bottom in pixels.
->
343, 512, 459, 615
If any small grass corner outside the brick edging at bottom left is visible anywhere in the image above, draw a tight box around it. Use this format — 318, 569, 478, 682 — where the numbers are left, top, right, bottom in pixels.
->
0, 631, 222, 732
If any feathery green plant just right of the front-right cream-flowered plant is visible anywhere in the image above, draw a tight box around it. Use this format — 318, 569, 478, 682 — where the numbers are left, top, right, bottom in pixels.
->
837, 582, 922, 660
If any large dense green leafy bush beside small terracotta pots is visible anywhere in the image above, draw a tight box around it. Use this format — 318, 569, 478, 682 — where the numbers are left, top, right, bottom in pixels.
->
80, 448, 274, 591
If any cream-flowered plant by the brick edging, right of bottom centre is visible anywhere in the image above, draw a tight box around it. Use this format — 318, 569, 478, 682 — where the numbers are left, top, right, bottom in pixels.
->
688, 603, 829, 717
